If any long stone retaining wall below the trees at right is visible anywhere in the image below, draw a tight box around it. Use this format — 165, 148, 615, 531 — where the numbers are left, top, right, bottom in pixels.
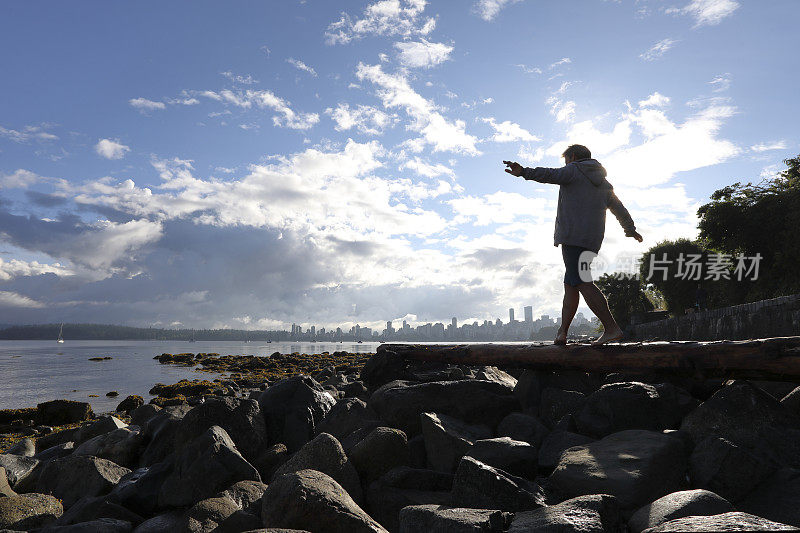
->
631, 294, 800, 341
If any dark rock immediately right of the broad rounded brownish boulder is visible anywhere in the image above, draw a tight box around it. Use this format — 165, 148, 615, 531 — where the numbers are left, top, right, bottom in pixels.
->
689, 437, 776, 502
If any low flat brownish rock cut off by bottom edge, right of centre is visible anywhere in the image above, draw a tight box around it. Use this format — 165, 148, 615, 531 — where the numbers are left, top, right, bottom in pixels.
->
400, 505, 512, 533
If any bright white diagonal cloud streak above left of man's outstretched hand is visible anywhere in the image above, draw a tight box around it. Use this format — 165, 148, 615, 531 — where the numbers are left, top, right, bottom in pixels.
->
356, 63, 480, 155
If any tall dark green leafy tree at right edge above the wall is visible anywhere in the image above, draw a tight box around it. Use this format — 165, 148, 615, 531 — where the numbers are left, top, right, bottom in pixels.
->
697, 156, 800, 301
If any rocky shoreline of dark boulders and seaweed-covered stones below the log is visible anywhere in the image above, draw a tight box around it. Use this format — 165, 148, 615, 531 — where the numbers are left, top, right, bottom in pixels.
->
0, 352, 800, 533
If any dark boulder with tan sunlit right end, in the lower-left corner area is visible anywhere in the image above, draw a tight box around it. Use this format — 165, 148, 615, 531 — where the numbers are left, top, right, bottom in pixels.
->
37, 455, 130, 508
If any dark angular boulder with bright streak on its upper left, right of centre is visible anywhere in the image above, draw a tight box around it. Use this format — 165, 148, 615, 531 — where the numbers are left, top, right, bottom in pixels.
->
420, 413, 492, 472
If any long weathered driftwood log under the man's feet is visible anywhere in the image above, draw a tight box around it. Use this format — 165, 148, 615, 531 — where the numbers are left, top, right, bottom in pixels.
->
377, 337, 800, 381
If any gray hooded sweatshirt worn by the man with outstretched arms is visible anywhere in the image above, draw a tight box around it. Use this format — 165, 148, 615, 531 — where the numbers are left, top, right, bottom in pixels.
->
522, 159, 636, 253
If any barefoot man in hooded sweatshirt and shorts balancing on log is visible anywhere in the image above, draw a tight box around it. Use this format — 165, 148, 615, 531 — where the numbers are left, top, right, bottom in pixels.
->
503, 144, 642, 344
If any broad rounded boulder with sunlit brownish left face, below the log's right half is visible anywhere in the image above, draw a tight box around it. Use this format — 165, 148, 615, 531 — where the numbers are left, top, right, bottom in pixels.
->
549, 429, 686, 510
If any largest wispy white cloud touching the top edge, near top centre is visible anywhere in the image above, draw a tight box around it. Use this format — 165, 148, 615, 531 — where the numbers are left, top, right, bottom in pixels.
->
325, 0, 436, 44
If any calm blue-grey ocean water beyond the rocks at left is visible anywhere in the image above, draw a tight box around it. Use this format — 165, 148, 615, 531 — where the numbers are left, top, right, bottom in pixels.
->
0, 339, 378, 413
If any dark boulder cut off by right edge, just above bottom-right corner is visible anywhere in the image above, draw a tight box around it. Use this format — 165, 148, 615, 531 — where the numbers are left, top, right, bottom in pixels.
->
736, 468, 800, 527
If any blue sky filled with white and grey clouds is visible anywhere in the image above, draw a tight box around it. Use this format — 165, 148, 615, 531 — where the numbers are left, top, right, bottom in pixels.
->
0, 0, 800, 328
